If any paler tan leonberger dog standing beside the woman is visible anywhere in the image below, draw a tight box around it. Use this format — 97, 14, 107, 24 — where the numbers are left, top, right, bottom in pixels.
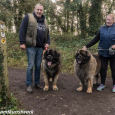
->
74, 49, 101, 93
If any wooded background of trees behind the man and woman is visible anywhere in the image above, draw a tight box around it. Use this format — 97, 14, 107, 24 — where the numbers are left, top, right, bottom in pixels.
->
0, 0, 115, 38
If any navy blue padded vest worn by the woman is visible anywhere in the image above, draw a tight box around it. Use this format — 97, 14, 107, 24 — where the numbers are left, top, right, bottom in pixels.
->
99, 23, 115, 57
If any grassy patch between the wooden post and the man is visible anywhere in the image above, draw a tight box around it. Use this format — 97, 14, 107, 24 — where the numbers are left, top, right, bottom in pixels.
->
6, 33, 27, 68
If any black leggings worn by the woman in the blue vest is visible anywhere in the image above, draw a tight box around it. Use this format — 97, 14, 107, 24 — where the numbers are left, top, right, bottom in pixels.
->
100, 56, 115, 85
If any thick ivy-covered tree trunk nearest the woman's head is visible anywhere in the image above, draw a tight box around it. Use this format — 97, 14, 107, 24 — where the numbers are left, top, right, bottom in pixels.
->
88, 0, 103, 35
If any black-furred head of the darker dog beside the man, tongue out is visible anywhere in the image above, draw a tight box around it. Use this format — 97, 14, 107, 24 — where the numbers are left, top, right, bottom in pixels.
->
44, 49, 60, 66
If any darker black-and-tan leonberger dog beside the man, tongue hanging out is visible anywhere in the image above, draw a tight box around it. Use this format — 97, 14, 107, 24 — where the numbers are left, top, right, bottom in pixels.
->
42, 49, 61, 91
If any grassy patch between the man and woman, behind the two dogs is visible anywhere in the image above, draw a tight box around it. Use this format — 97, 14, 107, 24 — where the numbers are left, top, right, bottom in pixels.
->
52, 35, 96, 74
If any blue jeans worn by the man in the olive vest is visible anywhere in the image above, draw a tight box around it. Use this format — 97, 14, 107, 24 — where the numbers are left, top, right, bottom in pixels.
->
26, 47, 43, 86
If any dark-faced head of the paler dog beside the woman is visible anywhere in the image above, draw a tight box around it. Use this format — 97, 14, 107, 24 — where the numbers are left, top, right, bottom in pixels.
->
75, 50, 90, 65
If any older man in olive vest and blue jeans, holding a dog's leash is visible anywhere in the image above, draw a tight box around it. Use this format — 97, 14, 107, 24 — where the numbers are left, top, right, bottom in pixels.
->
19, 4, 50, 93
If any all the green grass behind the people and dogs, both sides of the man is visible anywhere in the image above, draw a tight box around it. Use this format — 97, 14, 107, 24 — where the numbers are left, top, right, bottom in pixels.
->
6, 33, 97, 74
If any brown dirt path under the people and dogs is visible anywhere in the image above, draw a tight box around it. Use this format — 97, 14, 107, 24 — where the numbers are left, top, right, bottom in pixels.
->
8, 68, 115, 115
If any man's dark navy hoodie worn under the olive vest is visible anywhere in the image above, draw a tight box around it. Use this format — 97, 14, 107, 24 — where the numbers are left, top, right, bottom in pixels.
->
19, 13, 50, 47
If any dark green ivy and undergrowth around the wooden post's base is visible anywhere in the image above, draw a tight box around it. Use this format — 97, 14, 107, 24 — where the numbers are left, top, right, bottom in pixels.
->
0, 47, 18, 111
